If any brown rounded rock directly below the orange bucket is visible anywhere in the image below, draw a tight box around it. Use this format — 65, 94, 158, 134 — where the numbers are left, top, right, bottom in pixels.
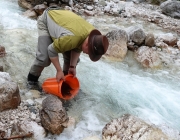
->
40, 95, 68, 134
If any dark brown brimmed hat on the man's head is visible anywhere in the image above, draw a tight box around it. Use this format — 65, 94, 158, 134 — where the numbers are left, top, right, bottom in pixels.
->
88, 29, 109, 61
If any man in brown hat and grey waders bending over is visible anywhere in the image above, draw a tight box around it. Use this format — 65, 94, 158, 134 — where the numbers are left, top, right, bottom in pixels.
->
28, 7, 109, 89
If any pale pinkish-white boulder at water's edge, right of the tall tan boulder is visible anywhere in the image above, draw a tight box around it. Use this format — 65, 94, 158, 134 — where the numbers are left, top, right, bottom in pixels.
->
135, 46, 162, 68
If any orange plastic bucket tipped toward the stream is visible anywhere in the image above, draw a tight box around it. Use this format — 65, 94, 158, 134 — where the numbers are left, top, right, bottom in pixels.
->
42, 74, 79, 100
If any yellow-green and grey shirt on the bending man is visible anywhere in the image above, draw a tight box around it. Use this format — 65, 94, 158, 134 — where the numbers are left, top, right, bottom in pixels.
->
47, 10, 95, 53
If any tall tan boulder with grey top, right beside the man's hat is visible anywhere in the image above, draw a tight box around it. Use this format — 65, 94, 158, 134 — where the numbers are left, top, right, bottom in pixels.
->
106, 29, 128, 61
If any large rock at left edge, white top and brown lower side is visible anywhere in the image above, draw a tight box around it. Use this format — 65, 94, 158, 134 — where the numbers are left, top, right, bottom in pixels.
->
0, 72, 21, 111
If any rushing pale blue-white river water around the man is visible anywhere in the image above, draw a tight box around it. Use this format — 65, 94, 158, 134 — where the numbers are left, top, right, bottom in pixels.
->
0, 0, 180, 140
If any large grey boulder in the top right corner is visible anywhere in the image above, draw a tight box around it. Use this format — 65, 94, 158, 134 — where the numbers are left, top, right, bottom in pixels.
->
160, 0, 180, 19
